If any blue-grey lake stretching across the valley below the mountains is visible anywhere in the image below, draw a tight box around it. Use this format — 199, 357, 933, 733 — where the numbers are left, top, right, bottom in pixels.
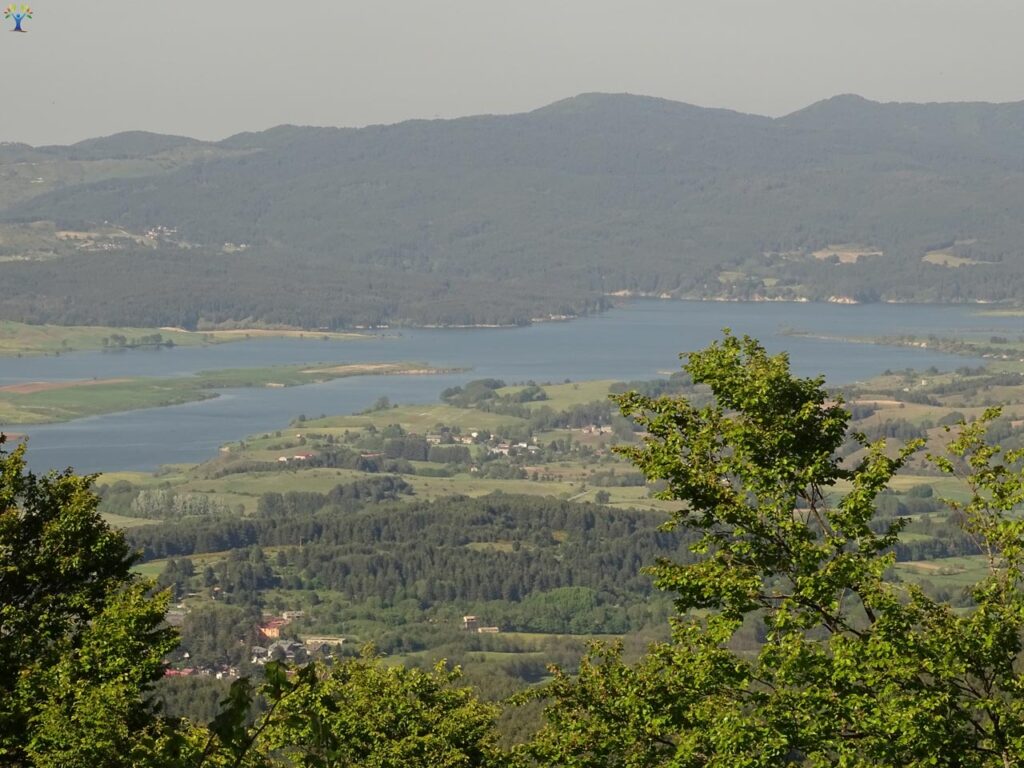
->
0, 300, 1024, 472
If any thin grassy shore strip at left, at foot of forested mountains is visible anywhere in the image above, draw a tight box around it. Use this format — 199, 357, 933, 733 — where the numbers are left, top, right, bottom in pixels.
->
0, 321, 368, 357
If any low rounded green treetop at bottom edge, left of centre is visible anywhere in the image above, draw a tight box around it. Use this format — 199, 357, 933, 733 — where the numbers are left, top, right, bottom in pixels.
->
189, 653, 507, 768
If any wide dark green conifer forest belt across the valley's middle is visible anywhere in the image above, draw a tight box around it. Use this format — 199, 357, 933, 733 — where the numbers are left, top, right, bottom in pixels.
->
129, 494, 686, 634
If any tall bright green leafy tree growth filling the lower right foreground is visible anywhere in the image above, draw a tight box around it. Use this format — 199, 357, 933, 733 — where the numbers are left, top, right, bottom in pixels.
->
528, 333, 1024, 768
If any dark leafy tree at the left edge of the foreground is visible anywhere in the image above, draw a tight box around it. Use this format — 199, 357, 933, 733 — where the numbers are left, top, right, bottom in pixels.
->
0, 435, 175, 768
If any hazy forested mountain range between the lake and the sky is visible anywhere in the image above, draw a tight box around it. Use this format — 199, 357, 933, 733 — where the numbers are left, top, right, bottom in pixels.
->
0, 94, 1024, 328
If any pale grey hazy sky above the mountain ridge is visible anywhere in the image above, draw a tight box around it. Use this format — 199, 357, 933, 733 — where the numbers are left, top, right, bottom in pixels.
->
0, 0, 1024, 144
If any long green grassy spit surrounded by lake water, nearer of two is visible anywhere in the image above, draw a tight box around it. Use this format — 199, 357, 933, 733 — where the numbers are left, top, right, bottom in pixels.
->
0, 362, 448, 425
